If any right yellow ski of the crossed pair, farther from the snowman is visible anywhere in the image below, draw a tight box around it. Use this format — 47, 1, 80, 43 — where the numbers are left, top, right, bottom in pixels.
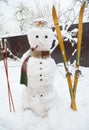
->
73, 2, 86, 101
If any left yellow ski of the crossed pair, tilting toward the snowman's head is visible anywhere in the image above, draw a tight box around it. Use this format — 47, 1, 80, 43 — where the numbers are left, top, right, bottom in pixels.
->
52, 6, 73, 107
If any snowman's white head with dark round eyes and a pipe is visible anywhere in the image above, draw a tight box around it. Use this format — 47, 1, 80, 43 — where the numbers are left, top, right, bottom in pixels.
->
28, 28, 55, 51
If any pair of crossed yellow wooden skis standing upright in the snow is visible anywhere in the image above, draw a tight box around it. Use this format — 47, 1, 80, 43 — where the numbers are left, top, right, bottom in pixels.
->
52, 2, 85, 110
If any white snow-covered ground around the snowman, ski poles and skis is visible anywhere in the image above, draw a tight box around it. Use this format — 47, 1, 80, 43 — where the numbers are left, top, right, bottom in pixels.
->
0, 59, 89, 130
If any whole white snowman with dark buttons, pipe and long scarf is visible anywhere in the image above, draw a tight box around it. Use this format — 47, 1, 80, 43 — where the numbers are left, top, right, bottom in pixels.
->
21, 21, 58, 128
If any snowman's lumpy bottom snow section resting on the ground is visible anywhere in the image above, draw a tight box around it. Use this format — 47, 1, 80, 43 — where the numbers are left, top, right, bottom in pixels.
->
22, 87, 57, 117
